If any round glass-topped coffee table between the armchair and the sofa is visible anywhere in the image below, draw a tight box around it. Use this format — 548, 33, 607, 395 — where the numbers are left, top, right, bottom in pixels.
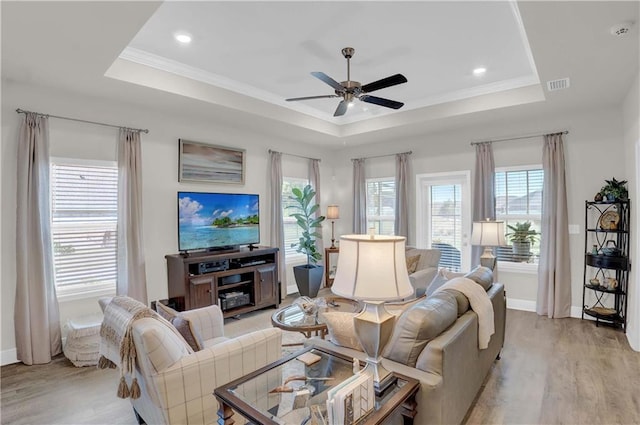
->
271, 297, 362, 345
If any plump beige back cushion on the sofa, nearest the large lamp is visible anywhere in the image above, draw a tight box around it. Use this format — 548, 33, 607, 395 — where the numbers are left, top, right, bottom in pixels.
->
383, 291, 458, 367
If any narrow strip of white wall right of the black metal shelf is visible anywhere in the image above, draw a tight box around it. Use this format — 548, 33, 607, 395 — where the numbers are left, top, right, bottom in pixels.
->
622, 76, 640, 351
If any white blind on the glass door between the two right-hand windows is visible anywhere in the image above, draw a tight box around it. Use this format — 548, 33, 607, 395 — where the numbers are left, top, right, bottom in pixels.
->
430, 184, 462, 271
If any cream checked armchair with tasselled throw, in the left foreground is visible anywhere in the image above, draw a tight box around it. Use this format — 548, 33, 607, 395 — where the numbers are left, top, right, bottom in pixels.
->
101, 300, 282, 425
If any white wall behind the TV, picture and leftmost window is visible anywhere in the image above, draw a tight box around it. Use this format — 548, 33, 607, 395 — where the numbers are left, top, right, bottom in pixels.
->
0, 81, 331, 364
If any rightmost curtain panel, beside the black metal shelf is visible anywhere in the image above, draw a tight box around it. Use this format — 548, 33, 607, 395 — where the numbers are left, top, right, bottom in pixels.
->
536, 134, 571, 318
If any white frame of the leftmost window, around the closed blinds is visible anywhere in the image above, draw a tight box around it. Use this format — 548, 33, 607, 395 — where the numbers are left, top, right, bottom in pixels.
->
49, 156, 118, 302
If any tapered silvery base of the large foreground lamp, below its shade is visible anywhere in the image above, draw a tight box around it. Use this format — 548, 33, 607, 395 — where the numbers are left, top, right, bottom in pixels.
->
353, 301, 396, 394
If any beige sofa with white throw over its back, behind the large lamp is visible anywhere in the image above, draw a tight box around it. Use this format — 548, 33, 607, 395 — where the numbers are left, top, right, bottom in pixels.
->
306, 283, 506, 425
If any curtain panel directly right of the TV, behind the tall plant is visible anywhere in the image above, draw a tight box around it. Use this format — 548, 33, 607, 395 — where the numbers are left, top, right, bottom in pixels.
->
269, 151, 287, 299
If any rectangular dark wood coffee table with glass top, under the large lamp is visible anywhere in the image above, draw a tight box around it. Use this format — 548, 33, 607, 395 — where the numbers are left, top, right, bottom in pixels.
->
214, 347, 420, 425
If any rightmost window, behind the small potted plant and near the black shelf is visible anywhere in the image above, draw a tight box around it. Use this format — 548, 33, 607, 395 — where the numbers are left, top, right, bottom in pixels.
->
495, 165, 544, 263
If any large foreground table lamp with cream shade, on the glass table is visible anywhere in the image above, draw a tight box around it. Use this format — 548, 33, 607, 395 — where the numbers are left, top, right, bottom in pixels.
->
331, 235, 414, 393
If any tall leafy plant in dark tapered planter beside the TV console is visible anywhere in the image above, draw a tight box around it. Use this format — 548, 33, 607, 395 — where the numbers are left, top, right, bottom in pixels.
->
287, 185, 325, 298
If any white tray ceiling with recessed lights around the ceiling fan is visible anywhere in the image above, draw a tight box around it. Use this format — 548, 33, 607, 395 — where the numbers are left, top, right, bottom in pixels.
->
1, 1, 638, 144
